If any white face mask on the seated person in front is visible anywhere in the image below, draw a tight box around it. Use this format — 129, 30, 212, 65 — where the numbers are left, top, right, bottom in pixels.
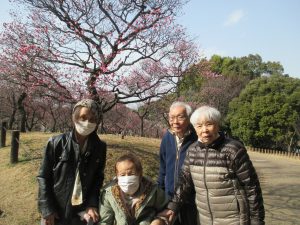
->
118, 175, 140, 195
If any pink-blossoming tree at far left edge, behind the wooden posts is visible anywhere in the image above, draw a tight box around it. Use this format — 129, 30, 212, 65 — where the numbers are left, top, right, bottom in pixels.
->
0, 21, 80, 132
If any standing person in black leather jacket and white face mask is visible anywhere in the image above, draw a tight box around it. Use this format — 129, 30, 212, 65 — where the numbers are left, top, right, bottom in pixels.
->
37, 99, 106, 225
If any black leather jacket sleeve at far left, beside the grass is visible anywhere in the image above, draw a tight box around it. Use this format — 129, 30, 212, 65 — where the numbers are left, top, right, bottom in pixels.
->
37, 138, 56, 218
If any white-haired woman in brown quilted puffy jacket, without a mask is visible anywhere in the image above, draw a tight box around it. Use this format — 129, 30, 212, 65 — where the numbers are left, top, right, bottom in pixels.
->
162, 106, 265, 225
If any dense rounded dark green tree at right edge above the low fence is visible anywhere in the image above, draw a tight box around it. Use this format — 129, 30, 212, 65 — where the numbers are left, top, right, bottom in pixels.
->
227, 75, 300, 150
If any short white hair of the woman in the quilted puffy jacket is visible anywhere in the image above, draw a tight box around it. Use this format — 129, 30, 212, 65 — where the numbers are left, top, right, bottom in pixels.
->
190, 105, 221, 126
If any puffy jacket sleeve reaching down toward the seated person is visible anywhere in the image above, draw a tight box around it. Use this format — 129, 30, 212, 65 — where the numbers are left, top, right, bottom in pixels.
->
167, 151, 195, 213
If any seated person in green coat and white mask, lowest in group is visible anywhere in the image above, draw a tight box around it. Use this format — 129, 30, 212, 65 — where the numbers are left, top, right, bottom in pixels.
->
99, 154, 168, 225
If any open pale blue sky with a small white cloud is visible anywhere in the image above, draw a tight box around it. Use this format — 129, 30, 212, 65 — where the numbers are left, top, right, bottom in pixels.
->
0, 0, 300, 78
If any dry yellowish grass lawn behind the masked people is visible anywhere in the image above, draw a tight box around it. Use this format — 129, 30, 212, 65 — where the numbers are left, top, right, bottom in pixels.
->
0, 132, 160, 225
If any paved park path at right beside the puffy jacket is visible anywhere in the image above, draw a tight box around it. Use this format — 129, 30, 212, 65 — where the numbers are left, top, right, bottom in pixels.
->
249, 152, 300, 225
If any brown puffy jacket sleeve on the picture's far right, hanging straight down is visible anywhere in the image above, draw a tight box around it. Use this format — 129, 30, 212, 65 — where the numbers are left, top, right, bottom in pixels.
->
233, 147, 265, 225
